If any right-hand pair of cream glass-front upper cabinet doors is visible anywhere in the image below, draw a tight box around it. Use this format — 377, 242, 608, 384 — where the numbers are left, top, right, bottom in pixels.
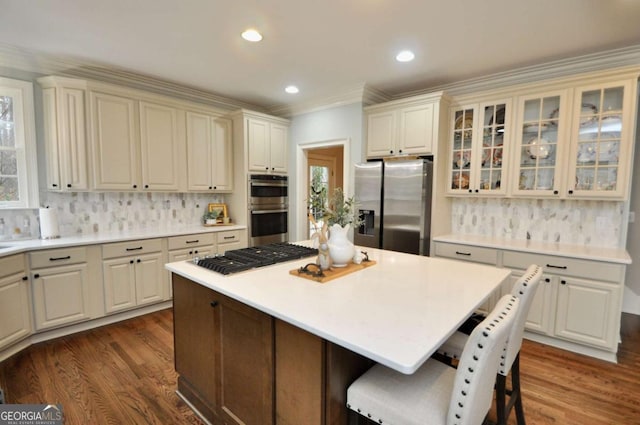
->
512, 80, 636, 199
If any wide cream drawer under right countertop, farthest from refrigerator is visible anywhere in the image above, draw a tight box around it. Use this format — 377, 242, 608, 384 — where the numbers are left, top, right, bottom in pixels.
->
502, 251, 625, 283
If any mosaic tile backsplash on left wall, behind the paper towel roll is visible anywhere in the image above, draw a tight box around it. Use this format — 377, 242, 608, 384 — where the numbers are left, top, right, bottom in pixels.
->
0, 192, 224, 240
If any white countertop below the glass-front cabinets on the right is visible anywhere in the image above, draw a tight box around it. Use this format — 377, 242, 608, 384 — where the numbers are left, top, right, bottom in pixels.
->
433, 235, 631, 264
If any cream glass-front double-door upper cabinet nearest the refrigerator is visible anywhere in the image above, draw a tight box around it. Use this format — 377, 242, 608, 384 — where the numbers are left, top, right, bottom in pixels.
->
447, 99, 511, 196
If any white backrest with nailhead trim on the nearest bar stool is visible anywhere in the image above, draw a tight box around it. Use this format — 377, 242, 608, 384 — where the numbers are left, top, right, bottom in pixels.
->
447, 295, 520, 425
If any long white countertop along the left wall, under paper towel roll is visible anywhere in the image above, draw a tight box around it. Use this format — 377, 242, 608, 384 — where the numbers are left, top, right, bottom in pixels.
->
0, 225, 246, 257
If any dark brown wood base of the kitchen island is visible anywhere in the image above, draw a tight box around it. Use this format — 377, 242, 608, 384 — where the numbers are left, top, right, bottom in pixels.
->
172, 274, 373, 425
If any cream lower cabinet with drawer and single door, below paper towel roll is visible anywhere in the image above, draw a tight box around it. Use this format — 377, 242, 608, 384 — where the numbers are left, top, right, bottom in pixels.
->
29, 247, 91, 330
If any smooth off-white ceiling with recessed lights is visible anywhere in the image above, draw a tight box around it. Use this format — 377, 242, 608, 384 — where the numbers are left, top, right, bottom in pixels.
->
0, 0, 640, 108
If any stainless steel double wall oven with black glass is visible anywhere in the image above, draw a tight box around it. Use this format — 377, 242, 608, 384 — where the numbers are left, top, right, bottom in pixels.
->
248, 174, 289, 246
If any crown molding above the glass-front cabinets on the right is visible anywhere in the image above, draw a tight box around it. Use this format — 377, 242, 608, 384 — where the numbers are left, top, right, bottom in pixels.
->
393, 44, 640, 99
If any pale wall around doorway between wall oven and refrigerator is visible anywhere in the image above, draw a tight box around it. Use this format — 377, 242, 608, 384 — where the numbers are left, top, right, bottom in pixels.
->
289, 103, 366, 241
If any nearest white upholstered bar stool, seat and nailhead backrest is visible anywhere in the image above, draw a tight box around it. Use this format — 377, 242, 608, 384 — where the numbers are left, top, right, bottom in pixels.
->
347, 295, 519, 425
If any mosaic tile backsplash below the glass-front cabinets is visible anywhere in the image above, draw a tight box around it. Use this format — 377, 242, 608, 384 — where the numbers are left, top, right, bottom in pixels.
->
451, 198, 624, 248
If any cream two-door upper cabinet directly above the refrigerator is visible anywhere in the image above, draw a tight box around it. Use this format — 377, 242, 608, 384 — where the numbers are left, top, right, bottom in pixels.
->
365, 93, 442, 158
